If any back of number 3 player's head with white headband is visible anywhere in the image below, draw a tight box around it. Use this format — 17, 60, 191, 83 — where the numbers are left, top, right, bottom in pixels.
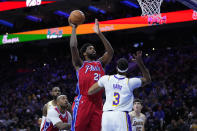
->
117, 58, 128, 73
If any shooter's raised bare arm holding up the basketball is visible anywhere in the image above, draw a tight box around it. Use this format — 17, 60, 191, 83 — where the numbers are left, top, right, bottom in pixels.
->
68, 20, 83, 70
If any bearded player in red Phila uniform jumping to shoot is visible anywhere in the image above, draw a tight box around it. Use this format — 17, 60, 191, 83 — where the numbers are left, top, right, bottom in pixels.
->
69, 19, 114, 131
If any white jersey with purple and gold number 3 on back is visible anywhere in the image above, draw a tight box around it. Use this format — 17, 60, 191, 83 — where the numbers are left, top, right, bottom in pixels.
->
98, 74, 142, 111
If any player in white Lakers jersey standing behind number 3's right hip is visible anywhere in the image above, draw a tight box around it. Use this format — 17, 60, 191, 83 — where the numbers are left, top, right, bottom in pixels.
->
129, 99, 146, 131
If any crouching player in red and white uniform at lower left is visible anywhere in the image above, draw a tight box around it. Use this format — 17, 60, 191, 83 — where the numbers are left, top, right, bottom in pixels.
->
40, 95, 72, 131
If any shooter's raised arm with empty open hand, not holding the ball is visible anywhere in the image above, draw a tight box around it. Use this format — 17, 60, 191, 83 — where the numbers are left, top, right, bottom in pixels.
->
94, 19, 114, 67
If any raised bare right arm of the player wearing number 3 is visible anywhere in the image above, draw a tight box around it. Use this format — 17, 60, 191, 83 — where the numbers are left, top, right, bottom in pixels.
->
133, 51, 151, 86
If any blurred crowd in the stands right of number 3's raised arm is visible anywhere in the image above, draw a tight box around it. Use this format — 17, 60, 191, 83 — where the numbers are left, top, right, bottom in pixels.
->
135, 47, 197, 131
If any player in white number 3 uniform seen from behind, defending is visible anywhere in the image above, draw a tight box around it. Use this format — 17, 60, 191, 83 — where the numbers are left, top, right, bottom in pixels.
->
88, 51, 151, 131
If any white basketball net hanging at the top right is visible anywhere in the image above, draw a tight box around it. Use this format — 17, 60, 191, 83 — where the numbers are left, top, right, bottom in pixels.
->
137, 0, 163, 16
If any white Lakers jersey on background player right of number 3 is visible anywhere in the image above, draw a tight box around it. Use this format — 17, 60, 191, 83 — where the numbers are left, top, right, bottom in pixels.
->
129, 112, 146, 131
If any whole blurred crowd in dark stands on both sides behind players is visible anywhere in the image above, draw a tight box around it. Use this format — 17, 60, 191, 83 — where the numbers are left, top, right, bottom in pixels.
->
0, 43, 197, 131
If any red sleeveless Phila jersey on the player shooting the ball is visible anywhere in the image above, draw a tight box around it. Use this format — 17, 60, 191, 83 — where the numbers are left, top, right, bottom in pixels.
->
76, 61, 105, 101
